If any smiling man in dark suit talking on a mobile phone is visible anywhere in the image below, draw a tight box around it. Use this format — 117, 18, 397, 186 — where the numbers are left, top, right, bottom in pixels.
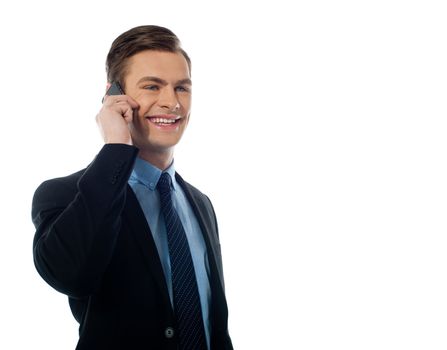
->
32, 26, 233, 350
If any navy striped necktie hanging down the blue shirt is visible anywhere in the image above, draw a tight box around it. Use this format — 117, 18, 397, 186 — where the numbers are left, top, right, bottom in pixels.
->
157, 173, 207, 350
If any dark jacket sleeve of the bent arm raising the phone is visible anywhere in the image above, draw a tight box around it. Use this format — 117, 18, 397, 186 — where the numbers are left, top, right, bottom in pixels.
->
32, 144, 138, 298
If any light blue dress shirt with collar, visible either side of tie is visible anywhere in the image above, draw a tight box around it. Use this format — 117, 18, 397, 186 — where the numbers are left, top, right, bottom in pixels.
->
129, 158, 211, 349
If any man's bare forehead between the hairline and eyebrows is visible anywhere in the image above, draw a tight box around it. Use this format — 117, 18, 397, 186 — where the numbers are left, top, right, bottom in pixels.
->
126, 50, 190, 80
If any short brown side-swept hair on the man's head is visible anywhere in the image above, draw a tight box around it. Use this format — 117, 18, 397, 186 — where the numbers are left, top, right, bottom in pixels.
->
106, 25, 191, 88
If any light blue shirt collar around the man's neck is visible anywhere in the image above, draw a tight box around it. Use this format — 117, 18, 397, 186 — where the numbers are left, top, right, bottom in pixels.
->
130, 157, 178, 191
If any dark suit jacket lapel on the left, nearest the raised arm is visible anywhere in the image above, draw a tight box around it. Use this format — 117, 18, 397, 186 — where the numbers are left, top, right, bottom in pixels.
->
124, 185, 172, 310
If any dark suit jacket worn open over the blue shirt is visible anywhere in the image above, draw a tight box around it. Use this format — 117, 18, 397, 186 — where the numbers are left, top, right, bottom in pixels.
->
32, 144, 233, 350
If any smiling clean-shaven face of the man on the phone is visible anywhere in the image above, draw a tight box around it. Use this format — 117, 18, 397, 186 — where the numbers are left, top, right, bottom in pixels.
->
124, 50, 191, 153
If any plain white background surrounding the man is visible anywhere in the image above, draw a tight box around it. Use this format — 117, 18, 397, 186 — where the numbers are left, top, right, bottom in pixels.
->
0, 0, 447, 350
